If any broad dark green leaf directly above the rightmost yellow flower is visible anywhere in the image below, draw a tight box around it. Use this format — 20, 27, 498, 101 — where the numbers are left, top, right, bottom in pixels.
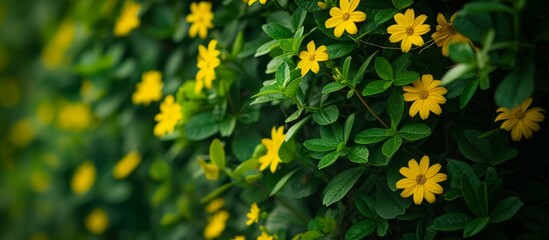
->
494, 60, 535, 109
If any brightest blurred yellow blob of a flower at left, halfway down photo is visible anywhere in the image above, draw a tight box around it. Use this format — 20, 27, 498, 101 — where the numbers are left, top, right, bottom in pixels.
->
57, 103, 92, 131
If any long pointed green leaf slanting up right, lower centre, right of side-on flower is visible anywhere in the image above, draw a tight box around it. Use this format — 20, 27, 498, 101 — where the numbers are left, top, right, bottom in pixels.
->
322, 167, 364, 206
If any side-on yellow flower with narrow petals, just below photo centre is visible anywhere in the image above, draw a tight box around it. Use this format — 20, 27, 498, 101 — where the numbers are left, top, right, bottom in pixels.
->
259, 126, 286, 173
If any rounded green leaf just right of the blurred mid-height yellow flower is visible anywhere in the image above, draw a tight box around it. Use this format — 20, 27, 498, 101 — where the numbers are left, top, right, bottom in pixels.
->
185, 112, 219, 141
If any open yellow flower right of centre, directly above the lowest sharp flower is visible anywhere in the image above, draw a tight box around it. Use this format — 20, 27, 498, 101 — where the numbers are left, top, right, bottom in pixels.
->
402, 74, 448, 120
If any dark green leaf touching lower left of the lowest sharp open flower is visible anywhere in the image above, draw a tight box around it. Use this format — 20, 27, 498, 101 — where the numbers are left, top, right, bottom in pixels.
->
375, 184, 411, 219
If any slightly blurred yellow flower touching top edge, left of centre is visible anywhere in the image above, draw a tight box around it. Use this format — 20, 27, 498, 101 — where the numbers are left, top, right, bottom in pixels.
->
186, 2, 214, 39
